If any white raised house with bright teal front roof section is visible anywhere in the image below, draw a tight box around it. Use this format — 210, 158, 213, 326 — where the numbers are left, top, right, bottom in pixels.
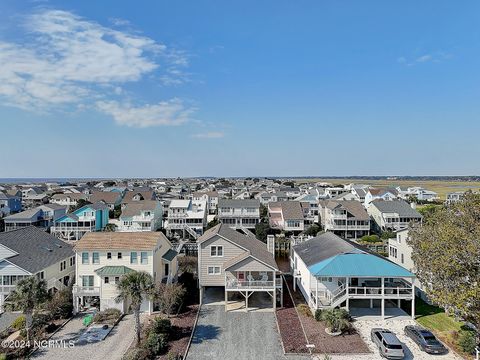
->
291, 232, 415, 318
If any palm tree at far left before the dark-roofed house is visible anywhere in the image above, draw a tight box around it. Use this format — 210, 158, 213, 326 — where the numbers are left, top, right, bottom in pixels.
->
5, 276, 48, 342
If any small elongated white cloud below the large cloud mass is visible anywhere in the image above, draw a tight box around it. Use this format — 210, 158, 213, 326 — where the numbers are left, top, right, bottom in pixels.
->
96, 98, 195, 128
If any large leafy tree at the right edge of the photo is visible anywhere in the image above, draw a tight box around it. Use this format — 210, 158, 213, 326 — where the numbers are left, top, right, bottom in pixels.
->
407, 192, 480, 329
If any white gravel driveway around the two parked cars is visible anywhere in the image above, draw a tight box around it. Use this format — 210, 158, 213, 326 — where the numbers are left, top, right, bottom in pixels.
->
317, 319, 462, 360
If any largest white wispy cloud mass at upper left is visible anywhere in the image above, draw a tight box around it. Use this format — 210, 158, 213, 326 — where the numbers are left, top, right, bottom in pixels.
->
0, 10, 188, 122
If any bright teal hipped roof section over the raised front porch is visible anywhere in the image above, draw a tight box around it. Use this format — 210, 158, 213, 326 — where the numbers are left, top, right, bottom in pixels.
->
308, 253, 415, 277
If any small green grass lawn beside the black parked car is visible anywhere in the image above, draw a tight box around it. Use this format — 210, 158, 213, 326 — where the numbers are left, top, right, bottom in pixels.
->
415, 298, 463, 332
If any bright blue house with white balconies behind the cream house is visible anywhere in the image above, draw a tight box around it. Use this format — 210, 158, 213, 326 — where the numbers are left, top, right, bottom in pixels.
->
51, 202, 109, 240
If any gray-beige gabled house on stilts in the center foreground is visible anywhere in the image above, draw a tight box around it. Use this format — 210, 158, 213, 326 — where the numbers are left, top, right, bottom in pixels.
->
197, 224, 283, 311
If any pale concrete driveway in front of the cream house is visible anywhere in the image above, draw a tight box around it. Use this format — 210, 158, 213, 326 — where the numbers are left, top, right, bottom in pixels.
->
32, 315, 135, 360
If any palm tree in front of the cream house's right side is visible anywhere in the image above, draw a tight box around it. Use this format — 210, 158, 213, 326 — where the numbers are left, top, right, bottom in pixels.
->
115, 271, 155, 346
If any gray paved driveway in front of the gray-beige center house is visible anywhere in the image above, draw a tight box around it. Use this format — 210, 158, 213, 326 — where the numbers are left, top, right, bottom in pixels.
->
187, 305, 306, 360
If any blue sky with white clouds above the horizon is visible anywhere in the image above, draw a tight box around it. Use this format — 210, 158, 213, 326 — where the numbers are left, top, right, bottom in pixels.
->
0, 0, 480, 178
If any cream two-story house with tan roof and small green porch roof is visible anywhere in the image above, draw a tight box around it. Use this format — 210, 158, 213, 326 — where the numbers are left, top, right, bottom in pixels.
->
73, 231, 178, 313
